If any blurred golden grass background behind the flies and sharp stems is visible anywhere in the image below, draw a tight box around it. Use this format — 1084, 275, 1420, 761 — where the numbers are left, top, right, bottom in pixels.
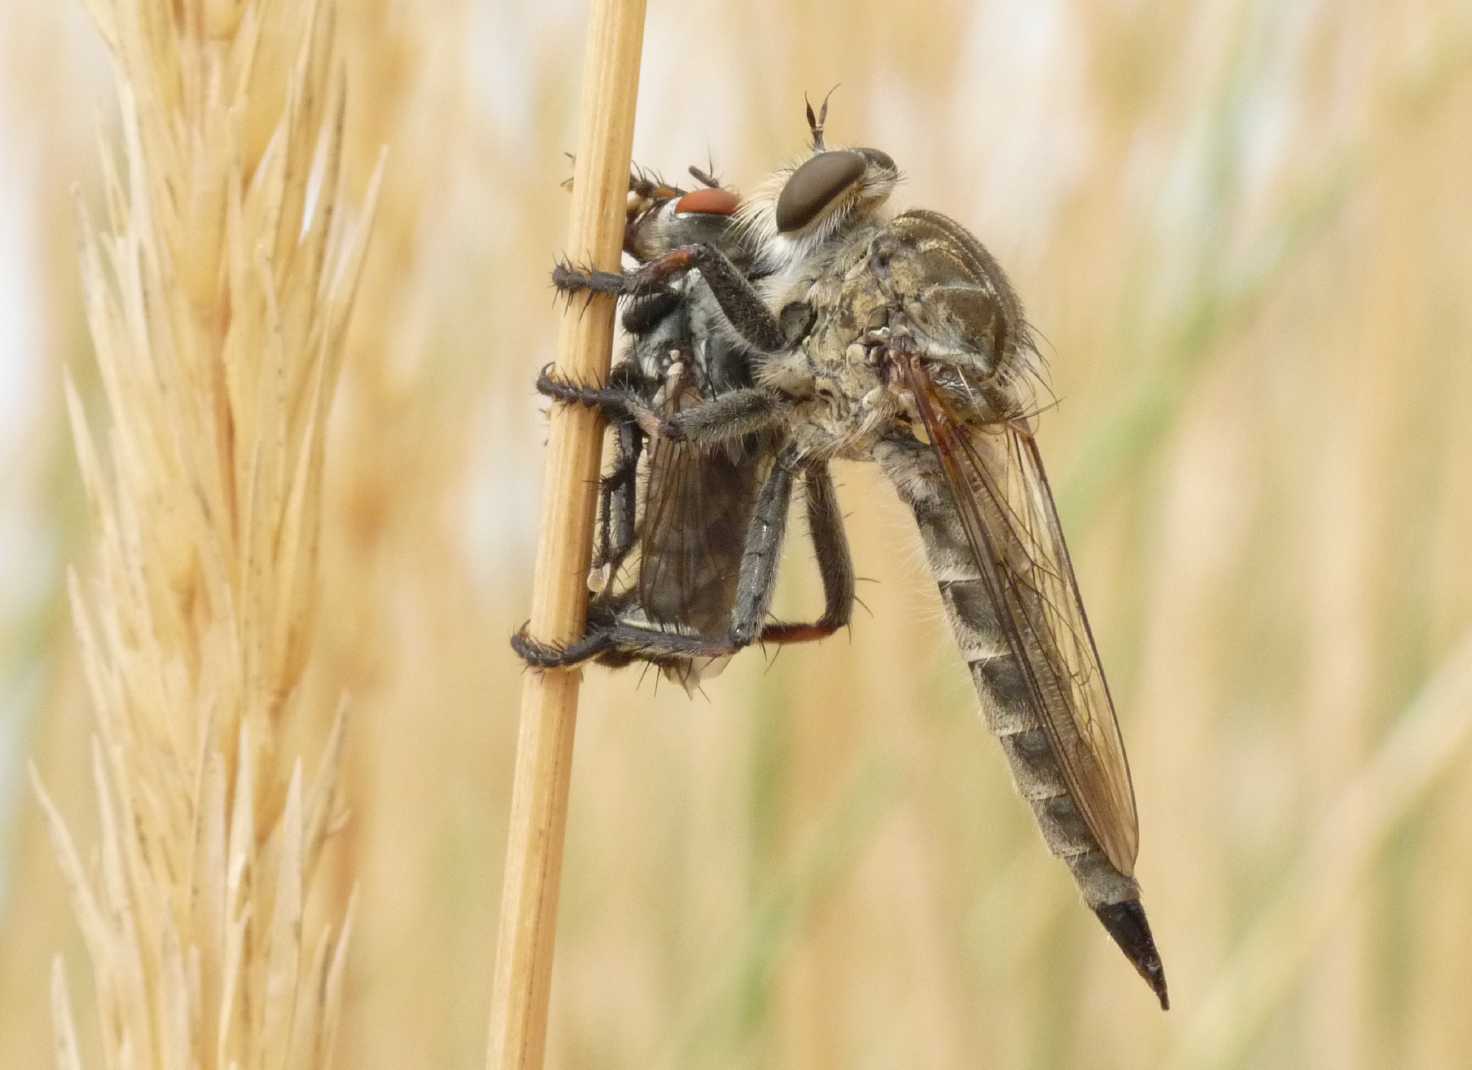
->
0, 0, 1472, 1067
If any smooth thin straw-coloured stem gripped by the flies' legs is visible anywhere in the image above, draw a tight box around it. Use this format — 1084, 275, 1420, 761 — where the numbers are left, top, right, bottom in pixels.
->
487, 0, 645, 1070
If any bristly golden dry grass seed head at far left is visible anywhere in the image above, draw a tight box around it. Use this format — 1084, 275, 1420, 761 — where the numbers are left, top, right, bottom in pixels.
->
37, 0, 377, 1067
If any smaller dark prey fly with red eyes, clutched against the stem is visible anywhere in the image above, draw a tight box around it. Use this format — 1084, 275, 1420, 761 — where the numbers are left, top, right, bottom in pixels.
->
512, 168, 854, 690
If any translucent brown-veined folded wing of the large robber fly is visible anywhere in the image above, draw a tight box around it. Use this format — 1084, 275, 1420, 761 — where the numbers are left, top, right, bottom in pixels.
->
901, 358, 1139, 876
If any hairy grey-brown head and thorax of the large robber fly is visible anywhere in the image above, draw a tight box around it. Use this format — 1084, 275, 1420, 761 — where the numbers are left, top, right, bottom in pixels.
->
736, 104, 1038, 459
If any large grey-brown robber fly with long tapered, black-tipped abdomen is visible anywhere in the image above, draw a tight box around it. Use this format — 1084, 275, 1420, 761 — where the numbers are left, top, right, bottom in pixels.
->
541, 102, 1169, 1008
